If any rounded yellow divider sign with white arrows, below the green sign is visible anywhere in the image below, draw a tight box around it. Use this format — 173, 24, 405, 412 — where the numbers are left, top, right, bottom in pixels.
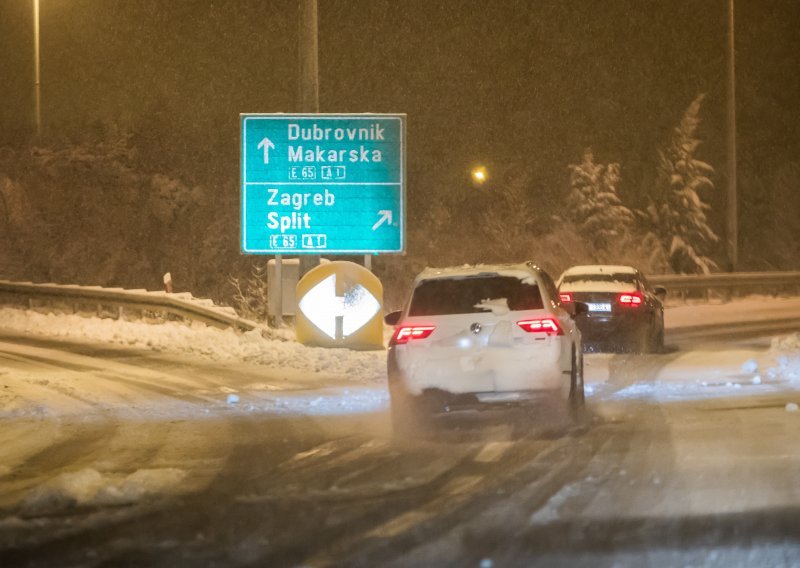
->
295, 261, 383, 349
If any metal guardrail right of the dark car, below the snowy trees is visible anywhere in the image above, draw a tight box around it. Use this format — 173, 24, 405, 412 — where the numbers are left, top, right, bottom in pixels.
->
648, 271, 800, 296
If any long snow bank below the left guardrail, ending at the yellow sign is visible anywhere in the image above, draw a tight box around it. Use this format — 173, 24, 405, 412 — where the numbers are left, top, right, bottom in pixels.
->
0, 308, 386, 382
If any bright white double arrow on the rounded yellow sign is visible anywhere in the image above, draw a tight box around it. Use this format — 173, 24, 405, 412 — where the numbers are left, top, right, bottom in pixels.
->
298, 274, 381, 339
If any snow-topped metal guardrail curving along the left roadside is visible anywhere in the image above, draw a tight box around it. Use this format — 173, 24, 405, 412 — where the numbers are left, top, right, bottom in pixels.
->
0, 280, 261, 331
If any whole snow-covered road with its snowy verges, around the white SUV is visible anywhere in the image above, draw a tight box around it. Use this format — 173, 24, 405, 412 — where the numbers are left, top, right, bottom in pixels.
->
0, 299, 800, 566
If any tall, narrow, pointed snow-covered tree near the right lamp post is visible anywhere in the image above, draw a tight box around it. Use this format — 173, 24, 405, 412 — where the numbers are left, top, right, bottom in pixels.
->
647, 94, 719, 274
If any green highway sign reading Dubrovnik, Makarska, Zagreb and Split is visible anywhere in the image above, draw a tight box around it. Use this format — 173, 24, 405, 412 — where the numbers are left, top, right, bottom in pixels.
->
240, 114, 405, 255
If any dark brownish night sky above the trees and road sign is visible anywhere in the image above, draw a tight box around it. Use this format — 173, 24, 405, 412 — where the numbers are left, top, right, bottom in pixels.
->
0, 0, 800, 226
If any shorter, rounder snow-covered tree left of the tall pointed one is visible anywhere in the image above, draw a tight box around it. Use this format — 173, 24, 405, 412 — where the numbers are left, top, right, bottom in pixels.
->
567, 148, 634, 249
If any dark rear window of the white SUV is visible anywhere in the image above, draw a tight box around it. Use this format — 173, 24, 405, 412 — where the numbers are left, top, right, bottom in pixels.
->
408, 276, 544, 316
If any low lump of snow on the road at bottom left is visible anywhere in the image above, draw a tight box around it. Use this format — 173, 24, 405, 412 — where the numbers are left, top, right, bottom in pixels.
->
20, 468, 186, 516
